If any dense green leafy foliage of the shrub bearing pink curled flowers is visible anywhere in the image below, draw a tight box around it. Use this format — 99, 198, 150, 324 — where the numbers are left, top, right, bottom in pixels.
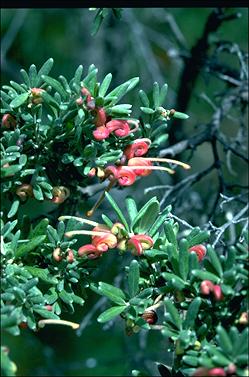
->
1, 58, 248, 376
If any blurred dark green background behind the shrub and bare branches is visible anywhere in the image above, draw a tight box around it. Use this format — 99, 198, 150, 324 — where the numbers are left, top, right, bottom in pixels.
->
1, 8, 248, 376
